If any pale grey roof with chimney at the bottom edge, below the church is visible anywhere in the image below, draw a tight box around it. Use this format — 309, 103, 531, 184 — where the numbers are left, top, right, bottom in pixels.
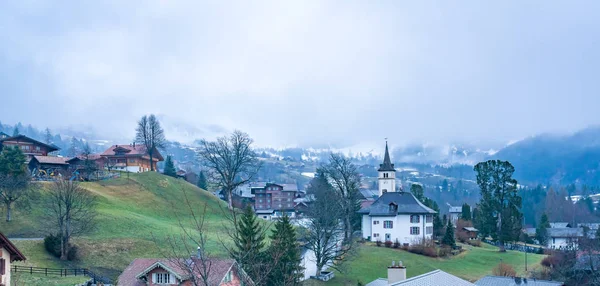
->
365, 261, 475, 286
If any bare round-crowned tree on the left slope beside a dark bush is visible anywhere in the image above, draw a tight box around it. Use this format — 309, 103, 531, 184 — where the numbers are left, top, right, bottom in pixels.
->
45, 180, 96, 260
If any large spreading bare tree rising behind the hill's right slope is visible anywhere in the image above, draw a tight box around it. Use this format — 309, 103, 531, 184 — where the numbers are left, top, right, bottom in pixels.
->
200, 130, 261, 210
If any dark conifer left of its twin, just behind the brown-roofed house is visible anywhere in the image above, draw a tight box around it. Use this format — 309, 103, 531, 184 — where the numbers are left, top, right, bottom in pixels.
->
230, 206, 266, 282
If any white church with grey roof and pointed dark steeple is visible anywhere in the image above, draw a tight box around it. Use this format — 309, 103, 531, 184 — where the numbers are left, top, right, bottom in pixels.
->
359, 142, 436, 245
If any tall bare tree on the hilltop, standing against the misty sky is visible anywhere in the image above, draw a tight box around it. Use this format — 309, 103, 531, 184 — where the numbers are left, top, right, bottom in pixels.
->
135, 114, 166, 171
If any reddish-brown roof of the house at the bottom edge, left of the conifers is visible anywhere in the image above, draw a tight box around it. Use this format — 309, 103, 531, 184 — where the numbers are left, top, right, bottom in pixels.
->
117, 258, 241, 286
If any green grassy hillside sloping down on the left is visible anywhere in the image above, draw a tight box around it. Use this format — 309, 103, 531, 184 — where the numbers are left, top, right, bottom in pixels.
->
0, 172, 229, 278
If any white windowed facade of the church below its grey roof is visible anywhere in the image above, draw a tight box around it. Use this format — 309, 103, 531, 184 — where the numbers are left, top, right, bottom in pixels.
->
362, 214, 433, 245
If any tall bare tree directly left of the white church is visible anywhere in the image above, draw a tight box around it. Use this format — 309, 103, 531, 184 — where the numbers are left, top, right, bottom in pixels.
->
321, 154, 360, 244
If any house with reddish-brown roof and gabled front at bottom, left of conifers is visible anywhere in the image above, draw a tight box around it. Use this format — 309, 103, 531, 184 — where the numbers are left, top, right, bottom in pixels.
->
117, 256, 254, 286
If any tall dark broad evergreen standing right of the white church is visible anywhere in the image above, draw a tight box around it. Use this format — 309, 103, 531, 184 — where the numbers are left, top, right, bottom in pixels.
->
474, 160, 522, 252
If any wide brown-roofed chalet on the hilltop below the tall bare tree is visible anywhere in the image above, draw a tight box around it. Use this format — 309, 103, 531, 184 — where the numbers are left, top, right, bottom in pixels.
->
100, 143, 164, 173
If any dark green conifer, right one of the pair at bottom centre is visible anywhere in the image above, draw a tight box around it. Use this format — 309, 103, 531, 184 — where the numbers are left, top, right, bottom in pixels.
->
266, 215, 303, 286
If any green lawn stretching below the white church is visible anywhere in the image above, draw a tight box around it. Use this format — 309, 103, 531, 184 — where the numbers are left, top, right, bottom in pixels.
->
306, 241, 544, 285
